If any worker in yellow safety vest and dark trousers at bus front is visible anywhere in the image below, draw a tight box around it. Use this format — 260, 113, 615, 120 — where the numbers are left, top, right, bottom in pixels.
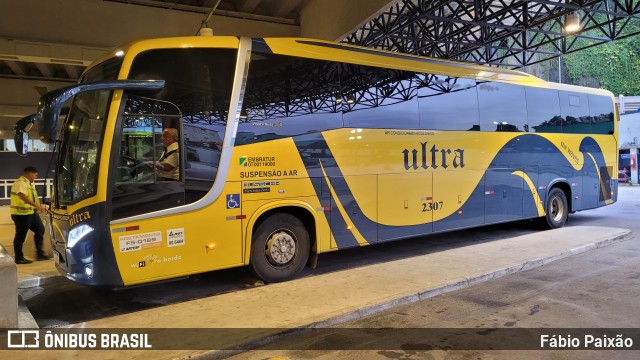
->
11, 166, 51, 264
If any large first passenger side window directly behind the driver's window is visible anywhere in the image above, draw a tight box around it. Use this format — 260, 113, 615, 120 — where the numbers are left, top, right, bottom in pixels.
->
235, 53, 346, 145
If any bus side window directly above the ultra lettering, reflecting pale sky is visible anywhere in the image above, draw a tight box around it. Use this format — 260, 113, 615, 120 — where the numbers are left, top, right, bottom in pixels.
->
418, 74, 480, 131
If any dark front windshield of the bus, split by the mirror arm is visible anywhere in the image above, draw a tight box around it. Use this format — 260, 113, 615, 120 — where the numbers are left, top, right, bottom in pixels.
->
56, 58, 122, 204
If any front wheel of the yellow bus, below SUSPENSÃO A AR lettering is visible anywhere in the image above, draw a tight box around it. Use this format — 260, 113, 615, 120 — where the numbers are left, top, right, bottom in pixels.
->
251, 213, 310, 282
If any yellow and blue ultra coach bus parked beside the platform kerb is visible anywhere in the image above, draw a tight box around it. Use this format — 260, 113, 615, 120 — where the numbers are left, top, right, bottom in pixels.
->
16, 36, 618, 286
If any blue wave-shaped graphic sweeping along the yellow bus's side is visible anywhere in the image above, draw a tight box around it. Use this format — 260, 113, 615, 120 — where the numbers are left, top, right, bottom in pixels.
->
294, 133, 611, 248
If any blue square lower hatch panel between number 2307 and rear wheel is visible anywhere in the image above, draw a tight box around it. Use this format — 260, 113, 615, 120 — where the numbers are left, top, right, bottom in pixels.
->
484, 168, 523, 224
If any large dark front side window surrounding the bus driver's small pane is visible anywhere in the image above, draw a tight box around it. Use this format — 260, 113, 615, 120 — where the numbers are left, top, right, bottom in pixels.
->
128, 47, 235, 203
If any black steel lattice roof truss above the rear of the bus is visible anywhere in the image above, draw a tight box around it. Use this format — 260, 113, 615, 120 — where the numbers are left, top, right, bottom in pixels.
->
345, 0, 640, 68
